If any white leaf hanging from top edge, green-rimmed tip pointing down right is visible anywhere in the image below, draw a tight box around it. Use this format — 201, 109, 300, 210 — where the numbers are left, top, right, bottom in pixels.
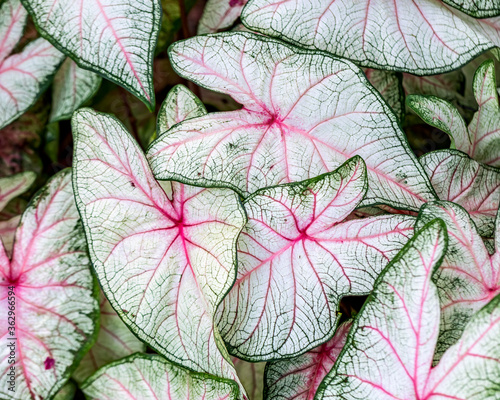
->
22, 0, 161, 110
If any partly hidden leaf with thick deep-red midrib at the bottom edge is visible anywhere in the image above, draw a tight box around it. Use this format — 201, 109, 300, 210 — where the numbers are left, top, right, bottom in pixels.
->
265, 321, 351, 400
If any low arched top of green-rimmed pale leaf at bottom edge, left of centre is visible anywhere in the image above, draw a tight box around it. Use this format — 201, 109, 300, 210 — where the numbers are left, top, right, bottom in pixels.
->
82, 354, 239, 400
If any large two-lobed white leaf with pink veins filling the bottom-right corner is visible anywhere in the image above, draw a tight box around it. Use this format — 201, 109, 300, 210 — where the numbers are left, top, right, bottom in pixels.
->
316, 219, 500, 400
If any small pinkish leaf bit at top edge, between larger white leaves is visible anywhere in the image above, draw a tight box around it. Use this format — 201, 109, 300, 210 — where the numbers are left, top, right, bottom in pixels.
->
198, 0, 247, 35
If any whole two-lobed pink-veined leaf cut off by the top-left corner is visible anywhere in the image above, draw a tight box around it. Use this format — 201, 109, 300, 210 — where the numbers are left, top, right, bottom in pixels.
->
0, 0, 63, 128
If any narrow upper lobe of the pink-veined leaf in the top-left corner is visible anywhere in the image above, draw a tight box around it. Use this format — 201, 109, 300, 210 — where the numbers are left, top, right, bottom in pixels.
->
0, 0, 28, 64
